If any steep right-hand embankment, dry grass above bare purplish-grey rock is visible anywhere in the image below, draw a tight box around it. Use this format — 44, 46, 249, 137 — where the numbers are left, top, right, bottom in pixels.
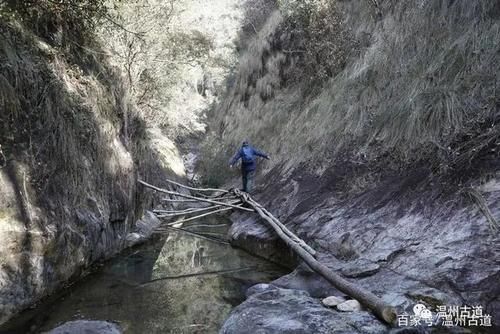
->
201, 0, 500, 332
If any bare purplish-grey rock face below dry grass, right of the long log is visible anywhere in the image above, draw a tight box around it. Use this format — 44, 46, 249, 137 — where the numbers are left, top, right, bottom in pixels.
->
227, 167, 500, 333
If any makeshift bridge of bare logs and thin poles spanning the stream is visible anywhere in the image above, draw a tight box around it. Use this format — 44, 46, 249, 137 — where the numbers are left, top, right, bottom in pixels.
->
138, 180, 397, 325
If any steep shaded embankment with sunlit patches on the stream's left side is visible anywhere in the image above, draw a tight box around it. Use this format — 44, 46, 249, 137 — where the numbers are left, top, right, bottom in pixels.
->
0, 12, 183, 323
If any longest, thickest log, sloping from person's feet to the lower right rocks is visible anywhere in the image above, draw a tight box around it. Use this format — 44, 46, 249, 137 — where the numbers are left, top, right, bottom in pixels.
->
239, 192, 397, 325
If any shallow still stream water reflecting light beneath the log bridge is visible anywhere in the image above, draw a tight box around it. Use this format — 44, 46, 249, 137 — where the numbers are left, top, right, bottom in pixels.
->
0, 219, 285, 334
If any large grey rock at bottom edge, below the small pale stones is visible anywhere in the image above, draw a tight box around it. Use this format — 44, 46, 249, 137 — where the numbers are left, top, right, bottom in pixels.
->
220, 288, 388, 334
